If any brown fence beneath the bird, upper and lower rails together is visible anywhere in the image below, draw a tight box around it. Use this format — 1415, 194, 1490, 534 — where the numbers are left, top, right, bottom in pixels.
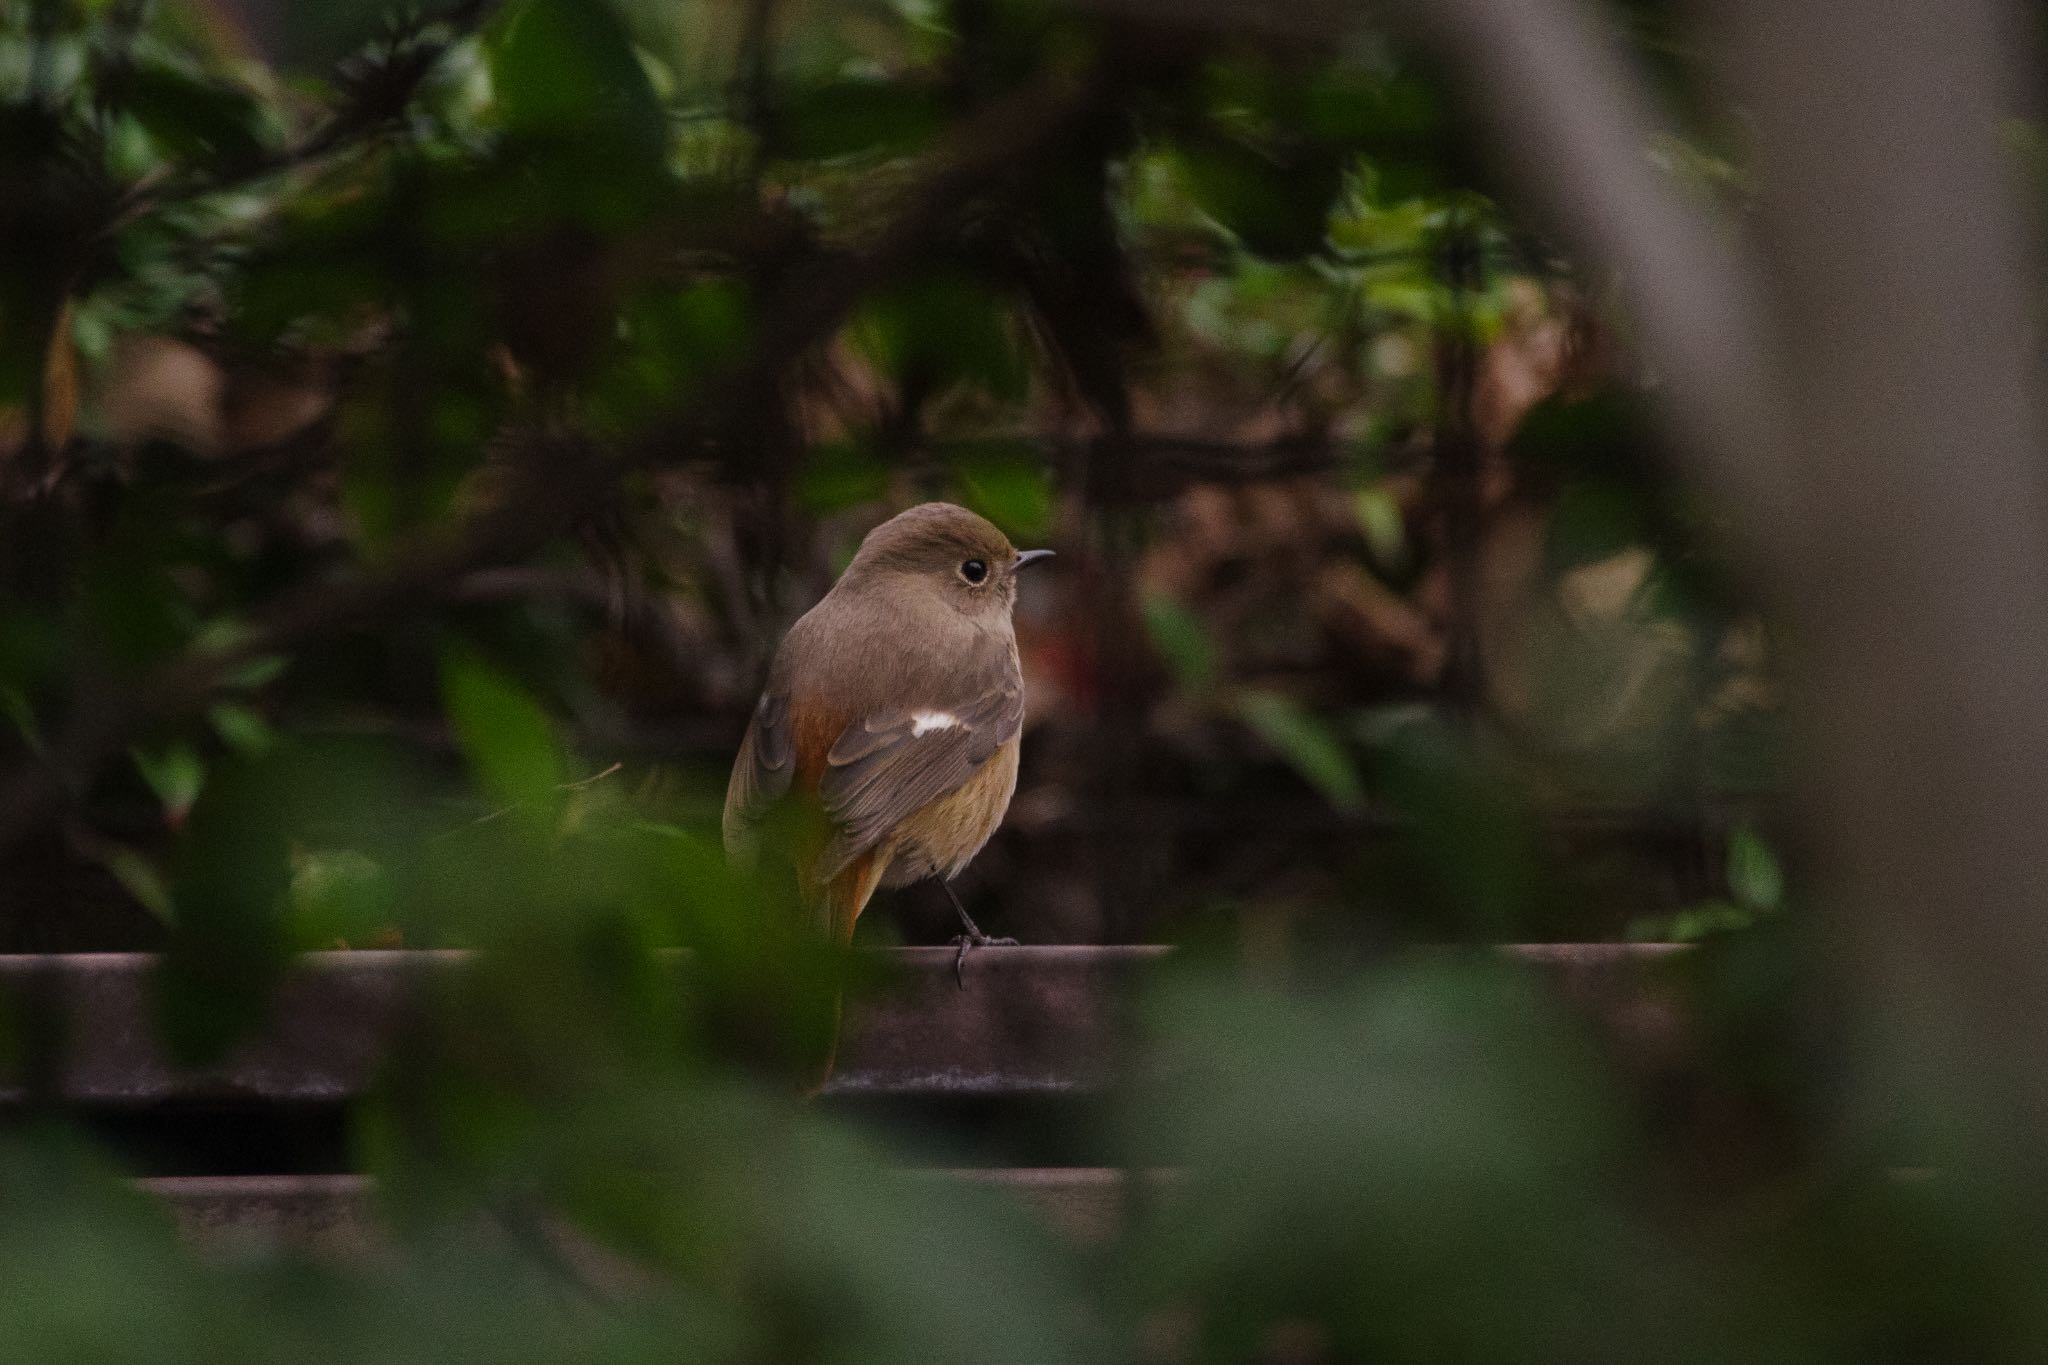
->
0, 943, 1686, 1254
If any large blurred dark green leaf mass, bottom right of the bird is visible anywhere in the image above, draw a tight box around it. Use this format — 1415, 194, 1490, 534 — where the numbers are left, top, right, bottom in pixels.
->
1126, 958, 1772, 1363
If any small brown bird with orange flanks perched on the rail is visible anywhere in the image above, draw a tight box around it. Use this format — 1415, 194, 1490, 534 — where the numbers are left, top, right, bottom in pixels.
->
725, 501, 1053, 974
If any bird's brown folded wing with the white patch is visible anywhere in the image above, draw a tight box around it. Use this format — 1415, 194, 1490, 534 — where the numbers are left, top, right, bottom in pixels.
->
817, 669, 1024, 878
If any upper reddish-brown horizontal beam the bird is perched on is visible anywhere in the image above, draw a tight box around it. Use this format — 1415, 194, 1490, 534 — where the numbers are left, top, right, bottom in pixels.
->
0, 943, 1681, 1111
